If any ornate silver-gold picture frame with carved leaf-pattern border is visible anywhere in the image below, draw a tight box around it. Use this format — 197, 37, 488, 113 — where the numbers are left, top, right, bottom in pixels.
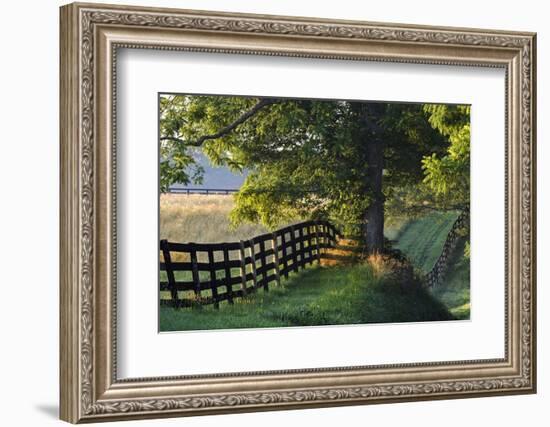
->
60, 3, 536, 423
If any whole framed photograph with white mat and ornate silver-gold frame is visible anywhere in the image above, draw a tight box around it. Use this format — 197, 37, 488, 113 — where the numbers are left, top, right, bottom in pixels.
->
60, 4, 536, 423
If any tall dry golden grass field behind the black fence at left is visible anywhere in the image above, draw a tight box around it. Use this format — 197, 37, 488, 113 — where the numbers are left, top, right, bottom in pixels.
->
160, 194, 267, 243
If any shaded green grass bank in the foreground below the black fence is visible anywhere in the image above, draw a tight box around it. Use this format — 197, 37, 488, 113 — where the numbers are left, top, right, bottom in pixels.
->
160, 264, 452, 331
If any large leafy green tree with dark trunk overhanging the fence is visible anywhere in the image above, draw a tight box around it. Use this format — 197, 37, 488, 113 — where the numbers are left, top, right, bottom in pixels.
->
160, 95, 462, 252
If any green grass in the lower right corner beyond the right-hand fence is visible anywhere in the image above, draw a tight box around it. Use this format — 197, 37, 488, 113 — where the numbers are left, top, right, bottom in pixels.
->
433, 238, 470, 319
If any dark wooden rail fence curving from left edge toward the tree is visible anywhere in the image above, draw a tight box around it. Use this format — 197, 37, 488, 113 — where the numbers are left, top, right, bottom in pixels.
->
160, 221, 340, 308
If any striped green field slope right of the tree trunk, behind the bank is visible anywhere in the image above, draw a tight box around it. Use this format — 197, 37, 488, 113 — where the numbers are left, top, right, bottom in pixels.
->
394, 212, 458, 273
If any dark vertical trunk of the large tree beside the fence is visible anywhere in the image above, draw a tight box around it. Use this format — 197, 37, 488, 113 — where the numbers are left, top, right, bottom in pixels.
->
363, 105, 384, 253
